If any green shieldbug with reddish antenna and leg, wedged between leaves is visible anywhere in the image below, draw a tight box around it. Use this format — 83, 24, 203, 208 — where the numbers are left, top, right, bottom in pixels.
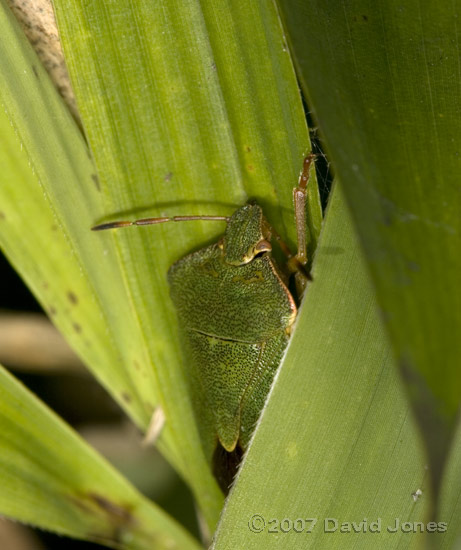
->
93, 154, 314, 492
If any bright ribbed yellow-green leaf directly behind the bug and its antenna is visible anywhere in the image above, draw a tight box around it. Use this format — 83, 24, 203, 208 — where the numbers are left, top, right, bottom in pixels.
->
51, 0, 321, 526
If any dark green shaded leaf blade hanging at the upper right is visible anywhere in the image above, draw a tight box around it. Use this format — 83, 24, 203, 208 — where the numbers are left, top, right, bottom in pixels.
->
280, 0, 461, 490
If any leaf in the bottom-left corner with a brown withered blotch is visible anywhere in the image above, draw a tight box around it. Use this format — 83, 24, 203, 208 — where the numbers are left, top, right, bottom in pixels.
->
0, 367, 200, 550
